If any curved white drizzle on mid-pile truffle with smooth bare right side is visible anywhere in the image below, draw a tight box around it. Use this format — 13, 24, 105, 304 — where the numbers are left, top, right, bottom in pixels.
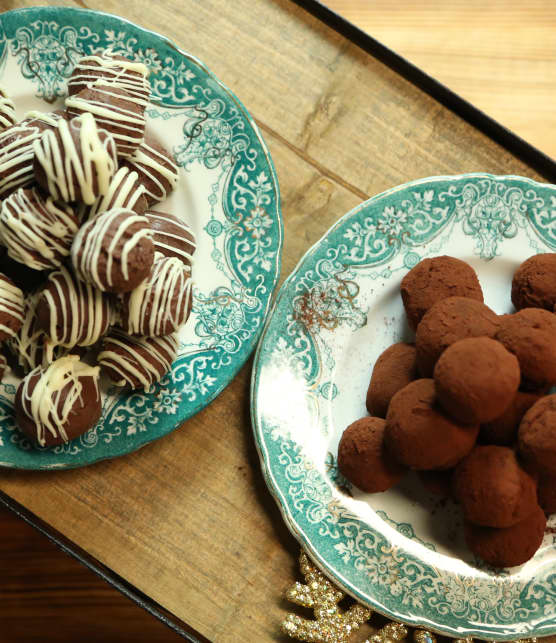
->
71, 208, 153, 290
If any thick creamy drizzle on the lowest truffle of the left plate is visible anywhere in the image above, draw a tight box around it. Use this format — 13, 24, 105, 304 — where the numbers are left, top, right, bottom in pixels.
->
20, 355, 100, 446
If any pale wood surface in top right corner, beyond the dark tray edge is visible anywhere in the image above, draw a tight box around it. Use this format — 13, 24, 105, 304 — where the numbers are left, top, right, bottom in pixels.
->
325, 0, 556, 157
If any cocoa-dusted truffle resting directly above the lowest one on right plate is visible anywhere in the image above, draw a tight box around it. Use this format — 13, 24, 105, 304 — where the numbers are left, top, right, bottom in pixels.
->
453, 445, 537, 527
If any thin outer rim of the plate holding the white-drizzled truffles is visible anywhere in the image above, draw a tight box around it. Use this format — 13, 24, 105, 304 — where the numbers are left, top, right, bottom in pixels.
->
0, 4, 284, 471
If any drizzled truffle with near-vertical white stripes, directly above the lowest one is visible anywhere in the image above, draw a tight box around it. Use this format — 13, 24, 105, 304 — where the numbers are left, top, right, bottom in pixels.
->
36, 267, 112, 347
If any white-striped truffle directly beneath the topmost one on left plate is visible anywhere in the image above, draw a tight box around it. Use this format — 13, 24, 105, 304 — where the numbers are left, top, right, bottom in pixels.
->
66, 80, 145, 157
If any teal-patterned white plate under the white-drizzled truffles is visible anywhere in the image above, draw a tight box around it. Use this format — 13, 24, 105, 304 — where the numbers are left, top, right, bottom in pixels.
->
0, 7, 282, 469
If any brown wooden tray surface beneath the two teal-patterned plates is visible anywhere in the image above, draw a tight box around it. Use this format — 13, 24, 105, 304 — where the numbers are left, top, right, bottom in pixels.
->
0, 0, 552, 642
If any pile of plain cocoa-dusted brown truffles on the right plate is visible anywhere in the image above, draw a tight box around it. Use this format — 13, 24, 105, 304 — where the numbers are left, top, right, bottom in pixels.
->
338, 254, 556, 567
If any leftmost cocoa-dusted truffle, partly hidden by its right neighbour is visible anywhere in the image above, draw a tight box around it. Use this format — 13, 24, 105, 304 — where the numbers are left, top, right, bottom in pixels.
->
338, 417, 405, 493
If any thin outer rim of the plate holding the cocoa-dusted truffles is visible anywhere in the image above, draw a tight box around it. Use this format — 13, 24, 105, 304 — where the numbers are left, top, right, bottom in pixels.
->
250, 172, 556, 641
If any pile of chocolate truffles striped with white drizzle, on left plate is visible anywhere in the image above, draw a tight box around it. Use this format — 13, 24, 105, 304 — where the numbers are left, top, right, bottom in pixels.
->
0, 52, 196, 446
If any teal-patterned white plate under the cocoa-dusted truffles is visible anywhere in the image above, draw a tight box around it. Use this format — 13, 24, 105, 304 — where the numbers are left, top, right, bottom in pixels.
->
252, 174, 556, 639
